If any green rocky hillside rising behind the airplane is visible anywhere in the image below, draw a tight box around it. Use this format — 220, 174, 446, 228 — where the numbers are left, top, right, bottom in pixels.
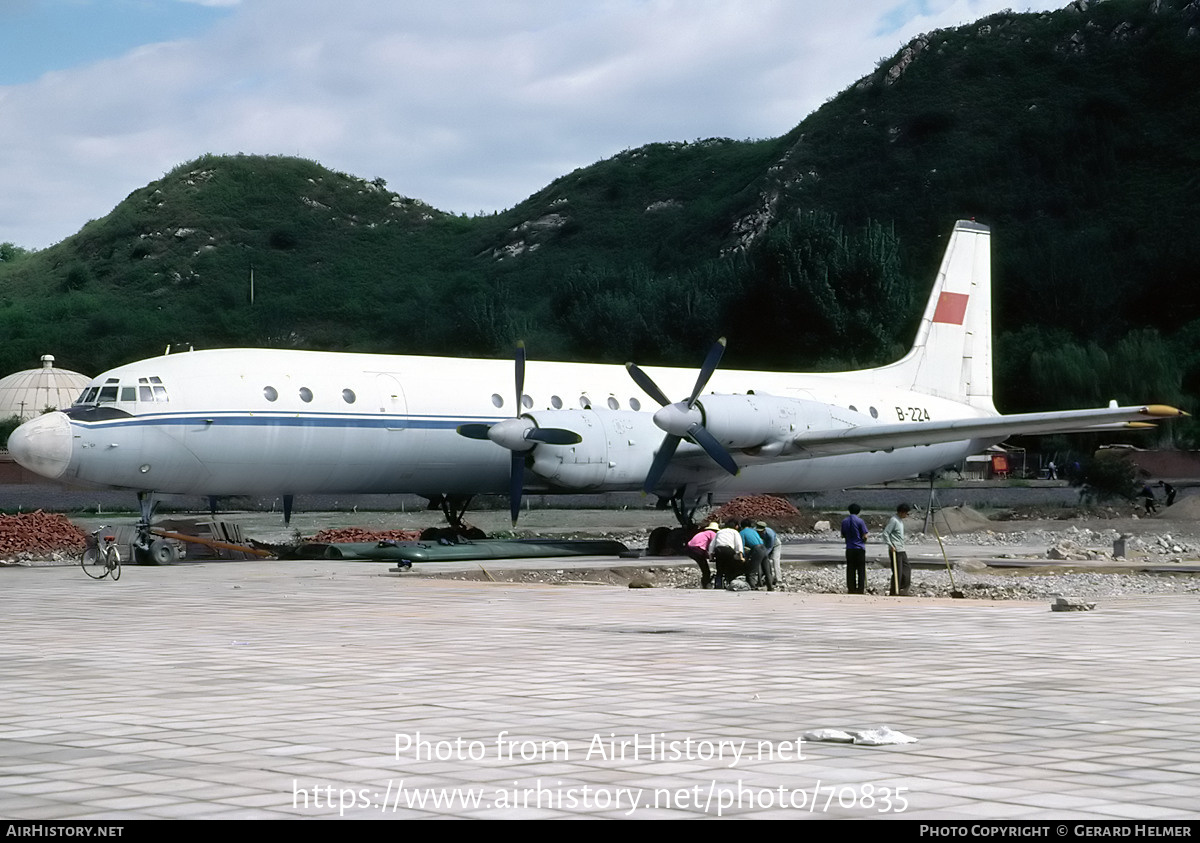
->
0, 0, 1200, 441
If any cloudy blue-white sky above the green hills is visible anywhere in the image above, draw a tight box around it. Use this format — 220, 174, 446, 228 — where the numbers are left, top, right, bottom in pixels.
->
0, 0, 1066, 249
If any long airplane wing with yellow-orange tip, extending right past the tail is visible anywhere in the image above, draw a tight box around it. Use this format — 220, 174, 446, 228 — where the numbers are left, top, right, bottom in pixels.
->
785, 403, 1188, 459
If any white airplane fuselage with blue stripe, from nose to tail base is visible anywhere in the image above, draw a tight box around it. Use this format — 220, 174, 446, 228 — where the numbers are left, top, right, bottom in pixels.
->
14, 349, 989, 495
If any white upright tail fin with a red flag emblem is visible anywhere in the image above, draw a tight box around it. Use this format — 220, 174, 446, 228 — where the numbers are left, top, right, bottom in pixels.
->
875, 220, 996, 413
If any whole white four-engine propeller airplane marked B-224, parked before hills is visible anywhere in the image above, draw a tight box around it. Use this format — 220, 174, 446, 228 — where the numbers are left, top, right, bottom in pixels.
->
8, 220, 1184, 562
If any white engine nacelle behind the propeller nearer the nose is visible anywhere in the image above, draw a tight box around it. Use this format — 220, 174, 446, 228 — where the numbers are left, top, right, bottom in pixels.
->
527, 409, 662, 491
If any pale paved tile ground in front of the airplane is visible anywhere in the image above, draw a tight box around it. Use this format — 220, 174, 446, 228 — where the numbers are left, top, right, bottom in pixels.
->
0, 562, 1200, 820
